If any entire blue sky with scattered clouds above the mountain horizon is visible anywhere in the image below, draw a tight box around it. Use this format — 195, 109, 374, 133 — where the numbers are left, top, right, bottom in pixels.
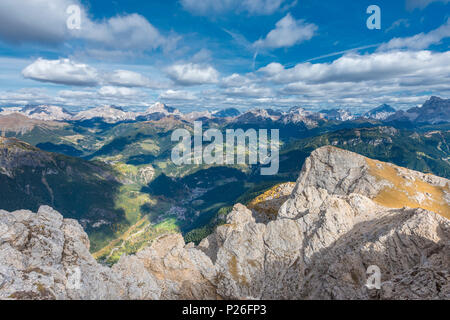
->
0, 0, 450, 113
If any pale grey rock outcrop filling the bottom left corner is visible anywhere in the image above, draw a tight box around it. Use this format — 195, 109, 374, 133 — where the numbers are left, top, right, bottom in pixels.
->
0, 206, 160, 299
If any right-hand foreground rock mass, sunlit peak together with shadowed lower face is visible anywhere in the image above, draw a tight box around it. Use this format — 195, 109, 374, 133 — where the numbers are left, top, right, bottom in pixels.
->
205, 147, 450, 299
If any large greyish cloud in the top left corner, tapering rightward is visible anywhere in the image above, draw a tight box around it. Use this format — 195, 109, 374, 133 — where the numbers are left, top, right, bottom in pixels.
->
0, 0, 179, 50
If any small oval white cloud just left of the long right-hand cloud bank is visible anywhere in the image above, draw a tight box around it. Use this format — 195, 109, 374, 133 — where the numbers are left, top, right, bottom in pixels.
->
167, 63, 219, 86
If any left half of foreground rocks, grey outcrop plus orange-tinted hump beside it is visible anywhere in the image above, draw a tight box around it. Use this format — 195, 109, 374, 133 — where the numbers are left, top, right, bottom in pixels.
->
0, 206, 217, 299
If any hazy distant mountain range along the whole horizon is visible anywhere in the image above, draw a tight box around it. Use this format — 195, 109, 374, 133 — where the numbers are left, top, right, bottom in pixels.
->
0, 97, 450, 124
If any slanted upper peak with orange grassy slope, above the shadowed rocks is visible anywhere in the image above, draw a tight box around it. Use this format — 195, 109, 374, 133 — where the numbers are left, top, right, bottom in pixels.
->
294, 146, 450, 218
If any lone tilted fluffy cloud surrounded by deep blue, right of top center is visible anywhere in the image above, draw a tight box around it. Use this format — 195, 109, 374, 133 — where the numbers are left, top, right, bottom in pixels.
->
254, 13, 317, 49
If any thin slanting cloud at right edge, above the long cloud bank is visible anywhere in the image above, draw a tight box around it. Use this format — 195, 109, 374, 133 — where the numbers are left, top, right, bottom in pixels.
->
378, 18, 450, 51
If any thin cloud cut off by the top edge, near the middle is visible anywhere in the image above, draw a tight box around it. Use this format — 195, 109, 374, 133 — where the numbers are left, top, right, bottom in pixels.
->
181, 0, 287, 15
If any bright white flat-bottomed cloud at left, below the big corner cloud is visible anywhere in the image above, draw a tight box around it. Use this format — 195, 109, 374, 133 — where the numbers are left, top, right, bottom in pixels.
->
22, 58, 99, 86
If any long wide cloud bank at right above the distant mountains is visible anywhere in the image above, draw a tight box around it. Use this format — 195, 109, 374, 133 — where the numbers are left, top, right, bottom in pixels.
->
258, 51, 450, 107
